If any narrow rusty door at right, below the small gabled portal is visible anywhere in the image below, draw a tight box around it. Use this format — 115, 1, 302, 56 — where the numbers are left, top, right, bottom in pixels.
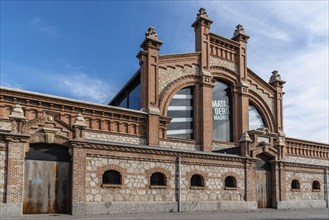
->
256, 170, 272, 208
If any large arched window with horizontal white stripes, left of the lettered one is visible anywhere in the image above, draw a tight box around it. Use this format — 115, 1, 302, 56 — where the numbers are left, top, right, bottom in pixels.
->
167, 87, 194, 139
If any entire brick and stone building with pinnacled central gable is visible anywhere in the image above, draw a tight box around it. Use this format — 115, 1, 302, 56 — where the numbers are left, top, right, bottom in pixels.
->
0, 8, 329, 217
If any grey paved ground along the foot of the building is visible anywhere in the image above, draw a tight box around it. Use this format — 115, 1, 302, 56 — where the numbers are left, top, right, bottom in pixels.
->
1, 208, 329, 220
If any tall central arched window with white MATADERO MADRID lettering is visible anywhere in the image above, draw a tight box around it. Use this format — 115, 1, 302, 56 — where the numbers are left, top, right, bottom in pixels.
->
212, 81, 232, 141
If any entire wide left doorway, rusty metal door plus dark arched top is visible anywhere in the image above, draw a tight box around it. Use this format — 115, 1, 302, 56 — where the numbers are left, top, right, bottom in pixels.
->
23, 145, 71, 214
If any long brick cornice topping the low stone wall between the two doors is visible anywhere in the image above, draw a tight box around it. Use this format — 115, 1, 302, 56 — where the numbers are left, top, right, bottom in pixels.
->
70, 140, 246, 162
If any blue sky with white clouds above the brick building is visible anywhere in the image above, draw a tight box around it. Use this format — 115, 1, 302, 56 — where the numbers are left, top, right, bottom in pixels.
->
0, 1, 329, 143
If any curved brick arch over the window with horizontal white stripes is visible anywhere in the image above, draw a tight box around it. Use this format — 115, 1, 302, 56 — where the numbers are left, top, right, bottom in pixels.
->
159, 75, 199, 116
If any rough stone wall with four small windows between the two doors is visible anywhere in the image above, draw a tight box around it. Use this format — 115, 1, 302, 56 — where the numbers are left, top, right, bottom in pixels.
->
84, 155, 245, 207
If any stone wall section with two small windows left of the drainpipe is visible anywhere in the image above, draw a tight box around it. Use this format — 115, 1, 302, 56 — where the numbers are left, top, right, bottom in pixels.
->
85, 157, 175, 202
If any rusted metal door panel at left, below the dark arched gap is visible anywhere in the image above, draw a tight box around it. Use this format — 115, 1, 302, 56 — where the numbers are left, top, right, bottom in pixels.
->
23, 160, 71, 214
